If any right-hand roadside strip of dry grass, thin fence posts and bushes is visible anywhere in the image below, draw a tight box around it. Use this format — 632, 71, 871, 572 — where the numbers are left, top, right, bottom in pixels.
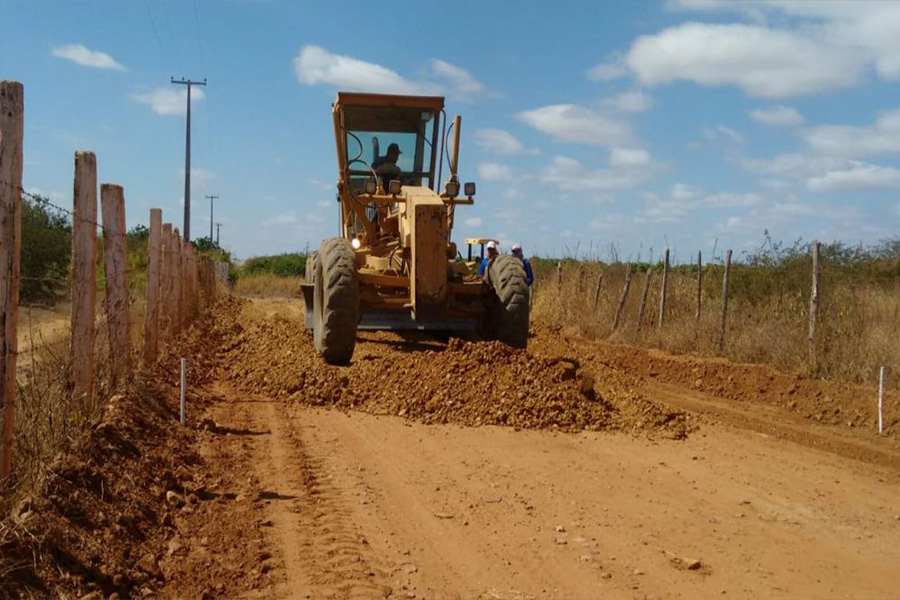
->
532, 240, 900, 402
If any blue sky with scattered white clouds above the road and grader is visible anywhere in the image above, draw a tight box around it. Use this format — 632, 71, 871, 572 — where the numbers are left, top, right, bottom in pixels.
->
0, 0, 900, 260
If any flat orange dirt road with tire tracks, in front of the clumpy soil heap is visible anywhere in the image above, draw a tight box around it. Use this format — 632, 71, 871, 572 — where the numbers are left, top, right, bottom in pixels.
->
162, 303, 900, 598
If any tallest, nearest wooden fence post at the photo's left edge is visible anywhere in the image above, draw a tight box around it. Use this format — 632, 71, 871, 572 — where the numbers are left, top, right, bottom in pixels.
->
0, 81, 25, 488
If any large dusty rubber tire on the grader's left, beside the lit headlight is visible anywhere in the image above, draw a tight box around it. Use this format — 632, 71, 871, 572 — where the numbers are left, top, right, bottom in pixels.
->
313, 238, 359, 365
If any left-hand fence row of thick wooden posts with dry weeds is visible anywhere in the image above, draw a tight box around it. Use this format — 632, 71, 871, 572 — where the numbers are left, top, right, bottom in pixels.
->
0, 81, 224, 492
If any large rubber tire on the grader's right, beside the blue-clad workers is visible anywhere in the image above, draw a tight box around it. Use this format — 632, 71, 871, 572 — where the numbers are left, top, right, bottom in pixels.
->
485, 255, 528, 348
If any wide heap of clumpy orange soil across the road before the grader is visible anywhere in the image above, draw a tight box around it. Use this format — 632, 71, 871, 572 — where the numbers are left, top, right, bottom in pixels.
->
222, 308, 689, 438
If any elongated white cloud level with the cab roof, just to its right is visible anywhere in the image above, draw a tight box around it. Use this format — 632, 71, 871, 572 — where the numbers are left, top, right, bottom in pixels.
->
516, 104, 631, 146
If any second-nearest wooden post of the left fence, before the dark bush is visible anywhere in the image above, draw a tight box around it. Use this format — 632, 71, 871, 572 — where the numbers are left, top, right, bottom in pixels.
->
70, 151, 97, 406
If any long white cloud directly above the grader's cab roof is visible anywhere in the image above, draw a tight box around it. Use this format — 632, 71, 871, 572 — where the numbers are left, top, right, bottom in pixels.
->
294, 45, 485, 101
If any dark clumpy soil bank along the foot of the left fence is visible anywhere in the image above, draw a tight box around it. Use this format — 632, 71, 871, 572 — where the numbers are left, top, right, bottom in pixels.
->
0, 301, 262, 600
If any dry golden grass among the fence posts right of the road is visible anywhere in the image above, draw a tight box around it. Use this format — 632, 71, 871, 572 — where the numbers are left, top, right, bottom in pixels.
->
532, 260, 900, 388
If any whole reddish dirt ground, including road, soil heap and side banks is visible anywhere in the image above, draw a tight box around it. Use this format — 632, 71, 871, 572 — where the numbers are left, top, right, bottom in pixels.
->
0, 300, 900, 600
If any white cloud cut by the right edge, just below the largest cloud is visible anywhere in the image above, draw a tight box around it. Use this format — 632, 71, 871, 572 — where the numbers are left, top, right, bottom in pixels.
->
804, 109, 900, 157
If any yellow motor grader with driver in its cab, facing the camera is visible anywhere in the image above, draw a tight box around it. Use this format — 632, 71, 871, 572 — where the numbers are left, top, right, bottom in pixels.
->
301, 92, 529, 364
